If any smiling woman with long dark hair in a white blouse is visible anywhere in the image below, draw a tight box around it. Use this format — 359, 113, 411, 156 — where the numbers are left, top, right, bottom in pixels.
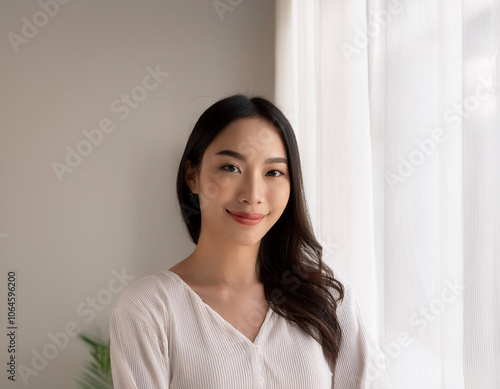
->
110, 95, 389, 389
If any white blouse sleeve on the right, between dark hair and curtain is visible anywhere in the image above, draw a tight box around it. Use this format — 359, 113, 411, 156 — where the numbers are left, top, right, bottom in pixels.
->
333, 283, 391, 389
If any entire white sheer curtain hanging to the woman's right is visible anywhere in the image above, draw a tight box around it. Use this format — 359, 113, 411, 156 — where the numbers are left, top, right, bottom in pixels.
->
276, 0, 500, 389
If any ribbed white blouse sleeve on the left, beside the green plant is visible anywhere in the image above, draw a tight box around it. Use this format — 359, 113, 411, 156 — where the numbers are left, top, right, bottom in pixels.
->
109, 307, 170, 389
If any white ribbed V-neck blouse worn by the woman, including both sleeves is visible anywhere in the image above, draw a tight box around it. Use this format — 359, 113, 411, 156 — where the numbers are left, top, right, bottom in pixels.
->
110, 270, 390, 389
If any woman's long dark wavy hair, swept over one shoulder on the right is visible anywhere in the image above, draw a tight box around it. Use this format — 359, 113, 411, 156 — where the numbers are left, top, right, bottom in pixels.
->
177, 94, 344, 373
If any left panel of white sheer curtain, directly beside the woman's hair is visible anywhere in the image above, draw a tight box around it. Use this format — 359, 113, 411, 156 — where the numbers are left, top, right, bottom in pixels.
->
276, 0, 383, 346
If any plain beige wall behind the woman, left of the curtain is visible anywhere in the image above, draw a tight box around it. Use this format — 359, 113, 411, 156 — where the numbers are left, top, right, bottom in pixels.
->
0, 0, 274, 389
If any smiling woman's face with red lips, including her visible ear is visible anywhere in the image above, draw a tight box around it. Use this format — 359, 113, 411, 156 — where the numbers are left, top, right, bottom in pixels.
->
186, 118, 290, 245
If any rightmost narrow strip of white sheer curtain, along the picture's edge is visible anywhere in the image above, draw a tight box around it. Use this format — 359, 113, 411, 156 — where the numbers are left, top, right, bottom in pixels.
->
460, 0, 500, 388
